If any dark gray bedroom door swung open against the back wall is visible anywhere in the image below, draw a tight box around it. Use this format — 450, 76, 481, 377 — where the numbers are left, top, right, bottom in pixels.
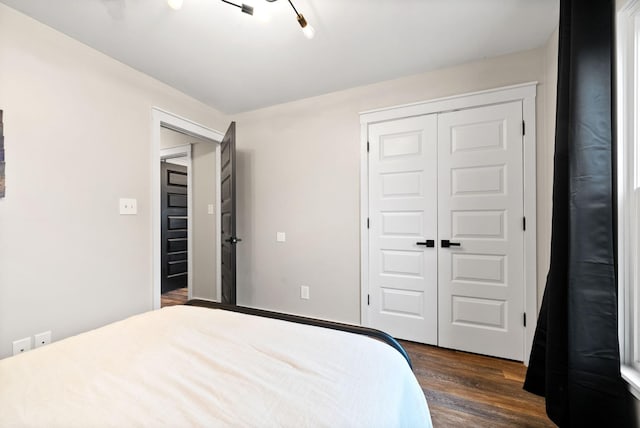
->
220, 122, 241, 305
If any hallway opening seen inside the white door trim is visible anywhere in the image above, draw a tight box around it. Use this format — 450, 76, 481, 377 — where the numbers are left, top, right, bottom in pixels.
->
160, 127, 218, 307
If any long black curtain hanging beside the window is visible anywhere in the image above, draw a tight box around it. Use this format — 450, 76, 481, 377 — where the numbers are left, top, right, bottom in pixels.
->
524, 0, 635, 427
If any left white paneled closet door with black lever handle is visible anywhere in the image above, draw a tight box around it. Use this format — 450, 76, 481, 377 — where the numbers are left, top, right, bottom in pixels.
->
369, 115, 438, 345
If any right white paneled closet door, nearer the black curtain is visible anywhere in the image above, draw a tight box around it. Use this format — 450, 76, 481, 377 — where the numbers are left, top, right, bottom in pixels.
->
438, 102, 524, 361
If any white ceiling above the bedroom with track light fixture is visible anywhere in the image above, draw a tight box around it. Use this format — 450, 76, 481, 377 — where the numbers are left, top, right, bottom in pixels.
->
0, 0, 559, 114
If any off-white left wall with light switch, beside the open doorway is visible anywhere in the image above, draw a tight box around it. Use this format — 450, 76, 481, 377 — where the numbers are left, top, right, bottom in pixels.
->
0, 4, 228, 357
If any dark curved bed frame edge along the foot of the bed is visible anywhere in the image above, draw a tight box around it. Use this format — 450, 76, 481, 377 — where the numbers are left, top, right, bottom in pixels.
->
186, 300, 413, 369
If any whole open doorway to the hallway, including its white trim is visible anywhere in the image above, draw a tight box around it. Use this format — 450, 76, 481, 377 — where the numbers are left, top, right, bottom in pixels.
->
152, 108, 223, 309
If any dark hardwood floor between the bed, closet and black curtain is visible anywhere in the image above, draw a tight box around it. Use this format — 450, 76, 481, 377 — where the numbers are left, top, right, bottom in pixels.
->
401, 341, 555, 428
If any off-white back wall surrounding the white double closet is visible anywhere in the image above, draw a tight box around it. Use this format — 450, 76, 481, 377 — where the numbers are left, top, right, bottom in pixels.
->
236, 47, 553, 323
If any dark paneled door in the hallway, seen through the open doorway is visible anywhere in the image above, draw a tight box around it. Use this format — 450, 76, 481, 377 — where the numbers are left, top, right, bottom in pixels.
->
160, 162, 189, 293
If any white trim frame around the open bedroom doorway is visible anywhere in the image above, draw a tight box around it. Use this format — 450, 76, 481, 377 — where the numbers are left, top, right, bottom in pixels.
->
151, 107, 224, 309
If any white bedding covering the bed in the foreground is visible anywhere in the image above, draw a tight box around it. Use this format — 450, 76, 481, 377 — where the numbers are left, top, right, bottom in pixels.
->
0, 306, 431, 427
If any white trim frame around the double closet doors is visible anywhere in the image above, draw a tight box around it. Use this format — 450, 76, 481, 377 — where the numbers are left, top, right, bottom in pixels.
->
360, 82, 538, 365
